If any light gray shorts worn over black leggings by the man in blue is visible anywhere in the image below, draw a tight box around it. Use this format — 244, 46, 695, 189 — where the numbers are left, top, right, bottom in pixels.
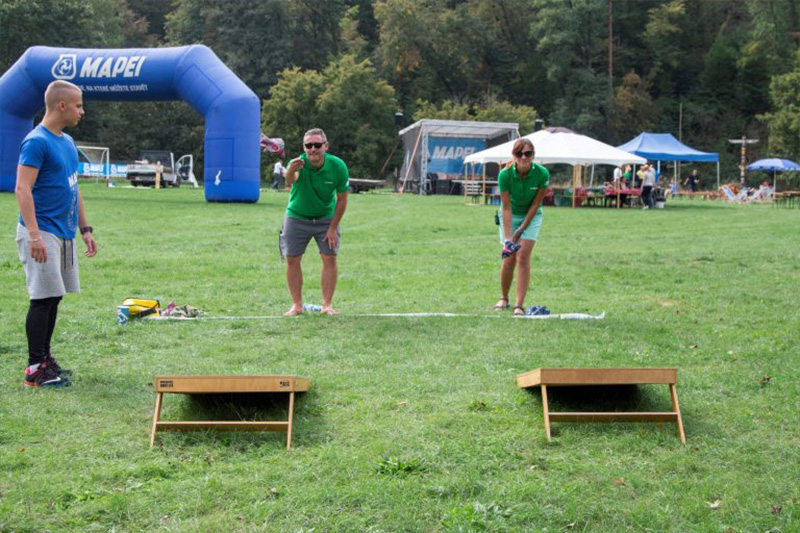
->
17, 224, 81, 300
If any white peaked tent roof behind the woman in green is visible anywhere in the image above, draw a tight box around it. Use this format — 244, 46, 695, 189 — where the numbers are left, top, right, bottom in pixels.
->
464, 130, 647, 166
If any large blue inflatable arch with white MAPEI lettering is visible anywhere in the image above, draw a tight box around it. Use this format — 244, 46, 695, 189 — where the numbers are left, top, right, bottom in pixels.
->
0, 45, 261, 202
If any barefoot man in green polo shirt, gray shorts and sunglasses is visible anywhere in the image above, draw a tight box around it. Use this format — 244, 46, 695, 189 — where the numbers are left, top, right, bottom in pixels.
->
280, 128, 350, 316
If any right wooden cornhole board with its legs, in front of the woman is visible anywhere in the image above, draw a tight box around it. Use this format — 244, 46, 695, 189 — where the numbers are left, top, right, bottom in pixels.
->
517, 368, 686, 443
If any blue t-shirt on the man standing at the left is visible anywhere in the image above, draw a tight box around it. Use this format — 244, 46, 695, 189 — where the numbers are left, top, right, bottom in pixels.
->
19, 124, 78, 239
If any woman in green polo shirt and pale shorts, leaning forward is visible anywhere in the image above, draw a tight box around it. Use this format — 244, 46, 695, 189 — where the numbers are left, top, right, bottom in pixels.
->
494, 138, 550, 315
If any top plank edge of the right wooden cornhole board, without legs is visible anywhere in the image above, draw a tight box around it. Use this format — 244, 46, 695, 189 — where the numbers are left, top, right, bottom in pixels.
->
517, 367, 678, 388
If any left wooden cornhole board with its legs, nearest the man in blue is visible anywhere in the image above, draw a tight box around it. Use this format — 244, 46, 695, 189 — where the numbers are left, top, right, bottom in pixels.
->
150, 376, 311, 450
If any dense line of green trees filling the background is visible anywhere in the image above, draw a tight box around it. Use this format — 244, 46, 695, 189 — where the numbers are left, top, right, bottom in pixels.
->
0, 0, 800, 184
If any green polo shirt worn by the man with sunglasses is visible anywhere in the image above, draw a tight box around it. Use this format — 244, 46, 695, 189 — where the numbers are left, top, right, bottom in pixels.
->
286, 154, 350, 220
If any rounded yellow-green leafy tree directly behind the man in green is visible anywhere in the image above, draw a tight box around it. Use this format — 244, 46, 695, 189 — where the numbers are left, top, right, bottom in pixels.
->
262, 55, 397, 177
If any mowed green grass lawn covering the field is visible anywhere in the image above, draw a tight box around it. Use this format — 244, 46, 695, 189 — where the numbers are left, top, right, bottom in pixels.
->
0, 183, 800, 532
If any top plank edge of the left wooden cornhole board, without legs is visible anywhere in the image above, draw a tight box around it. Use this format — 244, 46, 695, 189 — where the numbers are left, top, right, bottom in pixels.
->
155, 375, 311, 394
